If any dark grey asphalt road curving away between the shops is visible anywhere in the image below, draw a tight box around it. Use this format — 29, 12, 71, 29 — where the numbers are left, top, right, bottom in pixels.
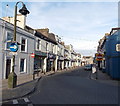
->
29, 67, 118, 104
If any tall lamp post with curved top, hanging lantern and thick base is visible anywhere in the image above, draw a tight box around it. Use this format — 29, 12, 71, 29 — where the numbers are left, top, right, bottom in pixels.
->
8, 1, 30, 88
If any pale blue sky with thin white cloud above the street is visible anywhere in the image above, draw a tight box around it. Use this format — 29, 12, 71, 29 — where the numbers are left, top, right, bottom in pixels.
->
1, 1, 118, 56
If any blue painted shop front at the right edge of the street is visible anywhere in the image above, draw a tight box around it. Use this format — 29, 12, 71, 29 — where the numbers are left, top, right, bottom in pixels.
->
105, 31, 120, 79
